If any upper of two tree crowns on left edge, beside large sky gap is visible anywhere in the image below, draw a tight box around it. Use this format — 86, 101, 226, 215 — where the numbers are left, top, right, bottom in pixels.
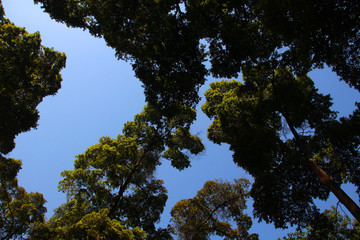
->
0, 1, 66, 154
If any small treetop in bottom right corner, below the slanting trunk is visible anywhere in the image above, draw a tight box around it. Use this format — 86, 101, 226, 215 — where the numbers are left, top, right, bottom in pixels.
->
283, 207, 360, 240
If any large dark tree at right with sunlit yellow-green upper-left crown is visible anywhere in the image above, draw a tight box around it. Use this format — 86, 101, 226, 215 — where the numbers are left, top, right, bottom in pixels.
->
202, 66, 360, 227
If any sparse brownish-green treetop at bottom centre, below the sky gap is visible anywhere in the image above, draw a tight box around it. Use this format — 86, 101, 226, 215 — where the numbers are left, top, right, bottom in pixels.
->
171, 179, 258, 240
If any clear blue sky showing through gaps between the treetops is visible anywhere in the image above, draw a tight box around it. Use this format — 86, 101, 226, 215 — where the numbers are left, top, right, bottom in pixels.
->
2, 0, 359, 239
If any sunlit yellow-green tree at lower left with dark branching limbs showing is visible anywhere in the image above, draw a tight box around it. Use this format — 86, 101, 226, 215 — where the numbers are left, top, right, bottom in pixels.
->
41, 135, 167, 239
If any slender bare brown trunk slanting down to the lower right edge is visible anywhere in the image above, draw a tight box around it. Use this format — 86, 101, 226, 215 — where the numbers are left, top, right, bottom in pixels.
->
283, 114, 360, 222
